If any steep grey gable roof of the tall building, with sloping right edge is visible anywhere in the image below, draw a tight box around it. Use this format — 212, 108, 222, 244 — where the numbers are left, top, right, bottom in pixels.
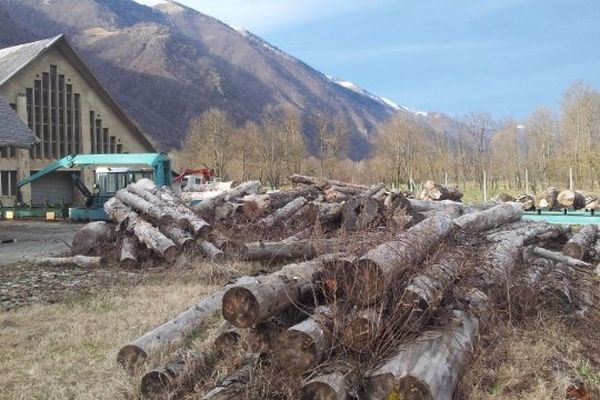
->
0, 34, 156, 152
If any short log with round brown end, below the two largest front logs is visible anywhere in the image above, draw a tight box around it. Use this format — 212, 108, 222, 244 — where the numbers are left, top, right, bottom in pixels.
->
273, 307, 333, 372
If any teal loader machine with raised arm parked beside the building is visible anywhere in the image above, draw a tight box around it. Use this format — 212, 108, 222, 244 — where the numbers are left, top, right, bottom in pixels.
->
9, 153, 172, 221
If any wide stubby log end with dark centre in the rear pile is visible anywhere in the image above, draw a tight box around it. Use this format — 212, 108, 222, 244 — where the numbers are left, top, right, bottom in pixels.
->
342, 197, 385, 230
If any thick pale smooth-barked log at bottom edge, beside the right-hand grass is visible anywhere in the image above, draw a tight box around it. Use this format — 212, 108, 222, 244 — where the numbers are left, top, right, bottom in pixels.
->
364, 311, 478, 400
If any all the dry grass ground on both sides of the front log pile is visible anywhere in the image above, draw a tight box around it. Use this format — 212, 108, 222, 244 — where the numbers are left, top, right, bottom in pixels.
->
0, 263, 600, 400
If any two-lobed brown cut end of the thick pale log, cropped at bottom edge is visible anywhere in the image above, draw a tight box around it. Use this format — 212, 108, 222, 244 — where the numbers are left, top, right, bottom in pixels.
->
365, 373, 428, 400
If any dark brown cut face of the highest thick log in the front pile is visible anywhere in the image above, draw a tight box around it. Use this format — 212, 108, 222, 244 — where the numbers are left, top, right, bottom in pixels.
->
343, 259, 386, 306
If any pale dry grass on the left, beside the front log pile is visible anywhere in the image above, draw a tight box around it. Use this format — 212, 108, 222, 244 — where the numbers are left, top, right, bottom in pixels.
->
0, 263, 251, 400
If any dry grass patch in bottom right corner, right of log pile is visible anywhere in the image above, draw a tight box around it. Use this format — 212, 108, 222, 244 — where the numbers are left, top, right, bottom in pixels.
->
459, 313, 600, 400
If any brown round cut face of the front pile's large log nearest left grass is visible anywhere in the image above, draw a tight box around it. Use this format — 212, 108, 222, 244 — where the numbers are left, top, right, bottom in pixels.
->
223, 287, 260, 328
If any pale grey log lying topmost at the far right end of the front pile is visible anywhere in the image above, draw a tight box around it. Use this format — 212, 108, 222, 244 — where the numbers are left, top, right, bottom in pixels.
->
454, 203, 523, 232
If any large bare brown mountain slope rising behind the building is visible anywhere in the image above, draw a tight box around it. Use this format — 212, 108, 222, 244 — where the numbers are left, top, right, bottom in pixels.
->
0, 0, 408, 158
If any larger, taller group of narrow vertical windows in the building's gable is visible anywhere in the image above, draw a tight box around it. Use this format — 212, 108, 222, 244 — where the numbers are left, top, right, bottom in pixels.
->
26, 65, 81, 160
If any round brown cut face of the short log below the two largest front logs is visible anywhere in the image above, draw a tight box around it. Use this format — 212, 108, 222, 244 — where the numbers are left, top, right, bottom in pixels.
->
273, 330, 320, 371
